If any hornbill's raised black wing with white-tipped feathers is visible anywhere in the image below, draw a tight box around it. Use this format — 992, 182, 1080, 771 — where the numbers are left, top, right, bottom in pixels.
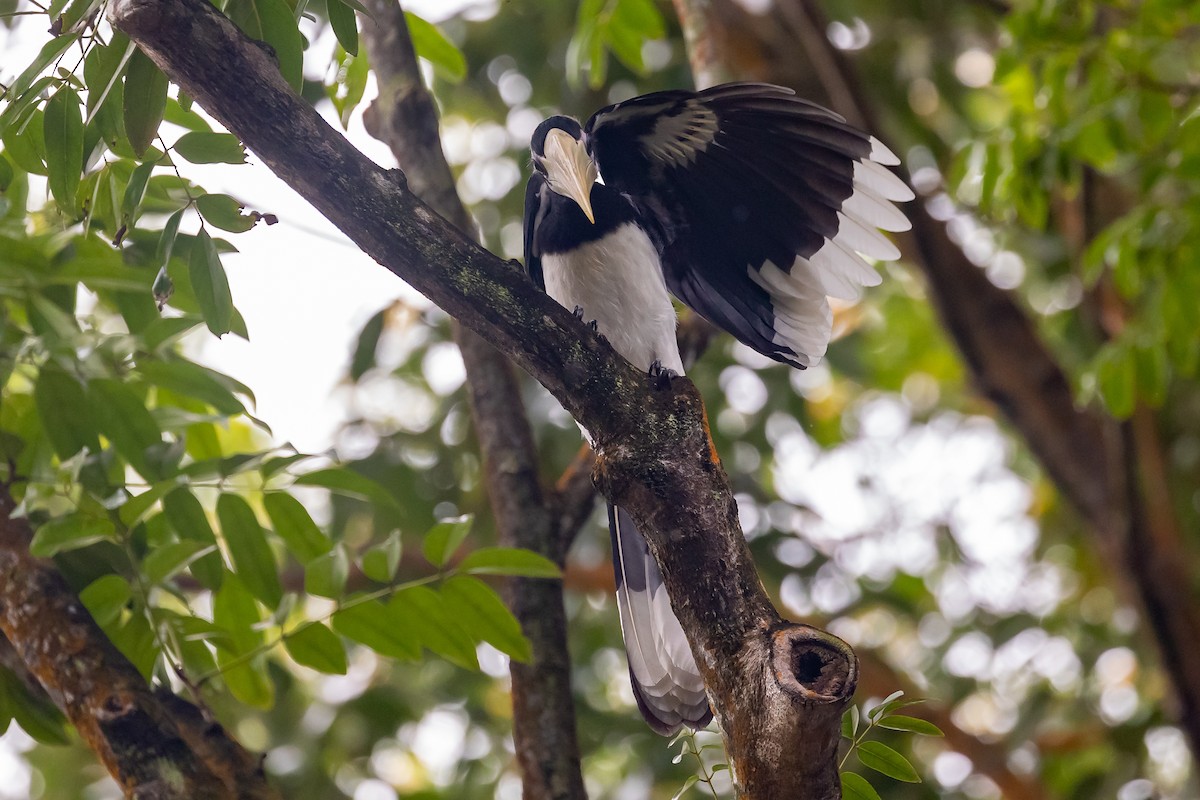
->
584, 84, 913, 367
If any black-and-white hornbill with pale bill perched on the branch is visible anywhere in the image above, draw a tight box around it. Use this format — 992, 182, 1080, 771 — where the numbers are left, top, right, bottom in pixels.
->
524, 84, 913, 734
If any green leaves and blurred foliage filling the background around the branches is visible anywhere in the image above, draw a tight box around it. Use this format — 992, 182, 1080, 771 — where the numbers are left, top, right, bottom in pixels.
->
0, 0, 1200, 800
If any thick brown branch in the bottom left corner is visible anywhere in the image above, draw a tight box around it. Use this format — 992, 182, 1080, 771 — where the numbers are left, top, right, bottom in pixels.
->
0, 487, 278, 800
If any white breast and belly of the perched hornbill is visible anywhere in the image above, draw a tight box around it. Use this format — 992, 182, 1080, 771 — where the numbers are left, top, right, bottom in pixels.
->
541, 223, 683, 374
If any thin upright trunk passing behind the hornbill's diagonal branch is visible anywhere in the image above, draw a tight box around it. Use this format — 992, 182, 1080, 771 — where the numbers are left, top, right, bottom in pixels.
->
362, 0, 592, 800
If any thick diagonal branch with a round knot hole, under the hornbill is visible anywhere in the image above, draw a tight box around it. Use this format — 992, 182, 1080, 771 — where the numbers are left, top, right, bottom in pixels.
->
109, 0, 858, 800
